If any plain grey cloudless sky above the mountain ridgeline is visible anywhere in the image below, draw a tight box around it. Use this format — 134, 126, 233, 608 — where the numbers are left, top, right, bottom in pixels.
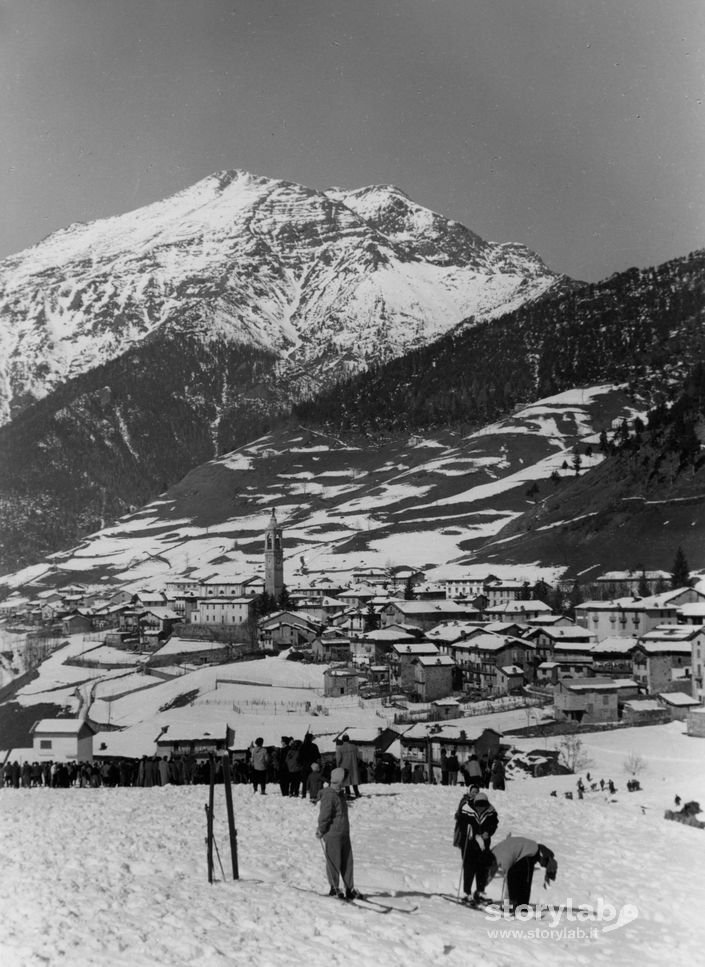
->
0, 0, 705, 280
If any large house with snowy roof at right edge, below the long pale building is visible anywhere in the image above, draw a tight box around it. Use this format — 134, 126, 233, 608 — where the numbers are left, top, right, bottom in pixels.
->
632, 624, 705, 695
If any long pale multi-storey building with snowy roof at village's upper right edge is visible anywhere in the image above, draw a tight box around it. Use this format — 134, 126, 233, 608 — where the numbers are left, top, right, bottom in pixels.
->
575, 588, 705, 641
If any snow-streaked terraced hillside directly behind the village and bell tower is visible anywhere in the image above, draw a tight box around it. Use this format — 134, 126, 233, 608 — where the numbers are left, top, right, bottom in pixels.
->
2, 386, 634, 587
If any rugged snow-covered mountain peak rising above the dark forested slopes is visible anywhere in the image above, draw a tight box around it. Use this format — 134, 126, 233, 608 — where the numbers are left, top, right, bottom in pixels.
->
0, 171, 566, 424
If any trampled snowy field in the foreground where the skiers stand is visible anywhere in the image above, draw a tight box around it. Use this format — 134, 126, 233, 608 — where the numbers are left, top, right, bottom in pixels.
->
0, 723, 705, 967
